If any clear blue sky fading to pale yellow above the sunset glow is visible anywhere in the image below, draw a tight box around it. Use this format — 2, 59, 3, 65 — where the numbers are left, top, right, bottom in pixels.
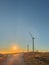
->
0, 0, 49, 51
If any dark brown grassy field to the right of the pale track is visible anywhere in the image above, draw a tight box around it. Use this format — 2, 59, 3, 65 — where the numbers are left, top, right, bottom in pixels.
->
24, 52, 49, 65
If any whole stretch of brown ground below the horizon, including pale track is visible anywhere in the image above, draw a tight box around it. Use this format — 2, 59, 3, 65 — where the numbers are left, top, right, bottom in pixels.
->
0, 52, 49, 65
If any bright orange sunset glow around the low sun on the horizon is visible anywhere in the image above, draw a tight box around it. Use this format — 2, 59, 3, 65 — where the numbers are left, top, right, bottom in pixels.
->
0, 44, 22, 54
